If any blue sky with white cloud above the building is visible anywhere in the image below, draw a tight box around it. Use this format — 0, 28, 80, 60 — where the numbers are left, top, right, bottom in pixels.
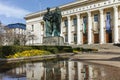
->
0, 0, 75, 25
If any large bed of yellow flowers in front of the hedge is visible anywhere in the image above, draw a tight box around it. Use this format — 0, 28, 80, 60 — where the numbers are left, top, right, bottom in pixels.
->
7, 50, 51, 58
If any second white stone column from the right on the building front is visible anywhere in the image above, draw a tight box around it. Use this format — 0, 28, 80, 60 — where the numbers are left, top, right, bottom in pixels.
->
100, 9, 105, 44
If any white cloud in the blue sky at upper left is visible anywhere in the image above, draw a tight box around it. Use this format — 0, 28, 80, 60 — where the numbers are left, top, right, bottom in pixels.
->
0, 3, 30, 19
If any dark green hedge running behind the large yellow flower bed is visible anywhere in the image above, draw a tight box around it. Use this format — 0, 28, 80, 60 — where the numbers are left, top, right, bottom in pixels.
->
0, 46, 73, 58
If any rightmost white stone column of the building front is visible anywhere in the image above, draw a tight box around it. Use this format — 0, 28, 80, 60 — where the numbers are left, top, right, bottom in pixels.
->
113, 6, 119, 43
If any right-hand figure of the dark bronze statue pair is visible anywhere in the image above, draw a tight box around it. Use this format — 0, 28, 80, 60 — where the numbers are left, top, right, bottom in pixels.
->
52, 7, 62, 36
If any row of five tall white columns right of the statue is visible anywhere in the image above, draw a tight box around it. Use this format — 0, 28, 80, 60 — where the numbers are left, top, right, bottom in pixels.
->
61, 6, 119, 45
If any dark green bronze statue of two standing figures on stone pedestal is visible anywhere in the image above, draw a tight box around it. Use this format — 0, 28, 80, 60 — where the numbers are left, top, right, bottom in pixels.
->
43, 7, 62, 37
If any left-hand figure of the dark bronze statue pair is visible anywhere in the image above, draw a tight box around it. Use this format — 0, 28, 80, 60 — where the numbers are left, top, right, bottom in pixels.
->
43, 7, 53, 37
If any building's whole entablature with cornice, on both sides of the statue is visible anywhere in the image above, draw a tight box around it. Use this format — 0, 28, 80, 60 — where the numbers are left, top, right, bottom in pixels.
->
25, 0, 120, 20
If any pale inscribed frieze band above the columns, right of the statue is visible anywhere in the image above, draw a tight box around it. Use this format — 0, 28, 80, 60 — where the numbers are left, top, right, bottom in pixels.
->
62, 0, 120, 16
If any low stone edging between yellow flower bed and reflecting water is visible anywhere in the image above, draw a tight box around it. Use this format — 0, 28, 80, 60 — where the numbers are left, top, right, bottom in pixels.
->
0, 53, 74, 63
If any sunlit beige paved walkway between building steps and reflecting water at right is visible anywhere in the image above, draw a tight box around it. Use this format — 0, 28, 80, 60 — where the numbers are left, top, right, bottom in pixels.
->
71, 50, 120, 67
